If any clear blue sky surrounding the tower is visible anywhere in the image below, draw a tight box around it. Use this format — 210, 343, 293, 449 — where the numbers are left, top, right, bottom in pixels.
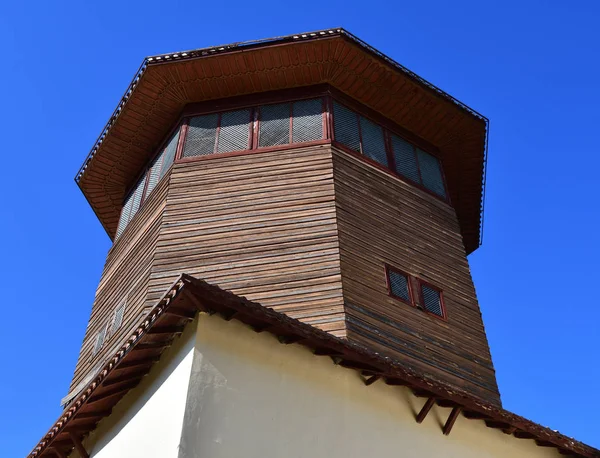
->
0, 0, 600, 456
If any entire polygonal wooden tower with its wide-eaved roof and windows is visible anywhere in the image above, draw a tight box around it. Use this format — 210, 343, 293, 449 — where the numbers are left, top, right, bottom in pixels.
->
63, 29, 500, 406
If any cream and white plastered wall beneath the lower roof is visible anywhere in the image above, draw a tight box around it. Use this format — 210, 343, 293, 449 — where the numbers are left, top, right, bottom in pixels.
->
74, 314, 561, 458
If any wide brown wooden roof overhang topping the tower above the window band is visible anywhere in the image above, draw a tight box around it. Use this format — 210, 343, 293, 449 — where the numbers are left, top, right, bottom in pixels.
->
75, 29, 488, 253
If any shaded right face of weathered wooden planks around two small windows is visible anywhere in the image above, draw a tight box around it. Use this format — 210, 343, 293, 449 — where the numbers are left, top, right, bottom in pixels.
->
333, 149, 500, 404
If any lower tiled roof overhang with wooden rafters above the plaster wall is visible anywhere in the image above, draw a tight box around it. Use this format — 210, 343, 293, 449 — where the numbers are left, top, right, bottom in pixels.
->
28, 274, 600, 458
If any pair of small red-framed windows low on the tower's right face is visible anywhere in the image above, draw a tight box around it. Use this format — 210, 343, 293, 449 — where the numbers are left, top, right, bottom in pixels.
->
385, 266, 446, 319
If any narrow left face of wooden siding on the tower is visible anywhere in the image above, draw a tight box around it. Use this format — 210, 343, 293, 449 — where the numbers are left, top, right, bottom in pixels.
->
71, 174, 169, 390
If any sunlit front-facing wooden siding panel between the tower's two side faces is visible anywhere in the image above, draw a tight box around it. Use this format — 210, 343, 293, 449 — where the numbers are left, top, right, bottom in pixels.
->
148, 145, 345, 336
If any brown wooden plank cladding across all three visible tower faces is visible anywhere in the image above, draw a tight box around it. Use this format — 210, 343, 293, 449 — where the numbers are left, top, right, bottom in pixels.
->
72, 145, 500, 404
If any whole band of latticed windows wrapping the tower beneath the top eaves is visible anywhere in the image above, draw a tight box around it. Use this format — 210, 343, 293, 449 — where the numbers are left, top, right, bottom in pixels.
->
116, 96, 447, 242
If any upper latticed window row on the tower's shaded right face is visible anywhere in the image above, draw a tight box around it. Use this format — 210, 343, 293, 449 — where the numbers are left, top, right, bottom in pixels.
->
333, 101, 447, 199
